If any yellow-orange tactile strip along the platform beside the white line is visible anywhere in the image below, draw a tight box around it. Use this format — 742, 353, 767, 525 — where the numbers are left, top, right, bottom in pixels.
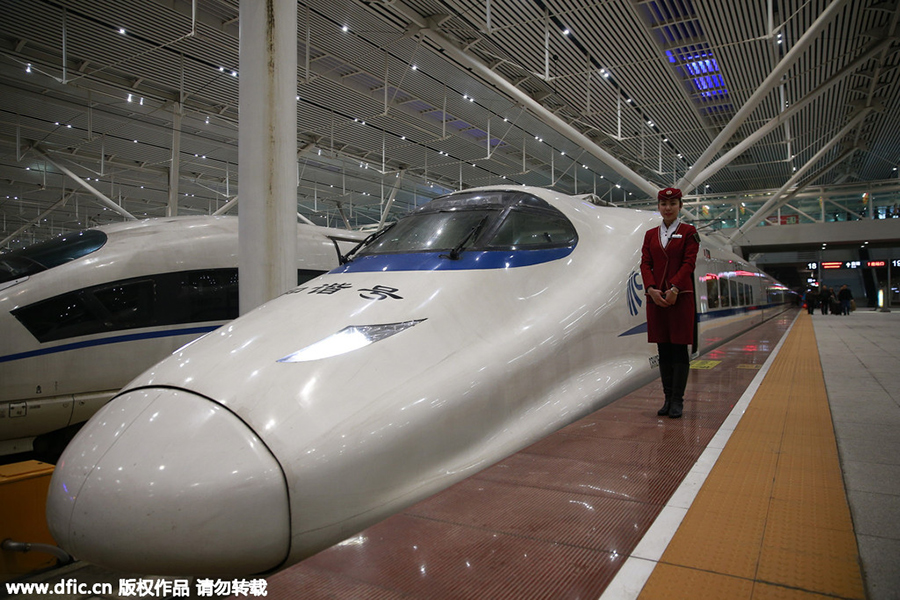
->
640, 313, 865, 600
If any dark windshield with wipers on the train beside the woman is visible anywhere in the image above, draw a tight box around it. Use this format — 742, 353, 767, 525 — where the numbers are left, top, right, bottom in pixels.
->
360, 190, 577, 258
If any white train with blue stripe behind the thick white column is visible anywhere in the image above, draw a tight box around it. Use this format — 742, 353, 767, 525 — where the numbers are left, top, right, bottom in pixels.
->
0, 217, 362, 456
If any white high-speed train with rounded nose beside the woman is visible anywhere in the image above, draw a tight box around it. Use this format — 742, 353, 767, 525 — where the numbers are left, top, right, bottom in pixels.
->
47, 187, 786, 575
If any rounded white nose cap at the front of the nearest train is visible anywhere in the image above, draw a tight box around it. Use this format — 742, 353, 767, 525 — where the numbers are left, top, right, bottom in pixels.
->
47, 388, 290, 575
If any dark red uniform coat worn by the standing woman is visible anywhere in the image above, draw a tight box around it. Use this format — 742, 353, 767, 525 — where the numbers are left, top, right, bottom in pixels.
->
641, 223, 700, 344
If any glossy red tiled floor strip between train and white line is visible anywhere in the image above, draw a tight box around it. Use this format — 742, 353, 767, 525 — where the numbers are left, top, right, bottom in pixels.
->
267, 311, 795, 600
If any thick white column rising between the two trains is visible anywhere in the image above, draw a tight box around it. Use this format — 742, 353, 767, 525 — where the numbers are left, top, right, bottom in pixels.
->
238, 0, 297, 314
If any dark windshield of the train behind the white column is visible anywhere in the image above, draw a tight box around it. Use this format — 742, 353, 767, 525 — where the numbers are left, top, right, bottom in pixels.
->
0, 229, 107, 283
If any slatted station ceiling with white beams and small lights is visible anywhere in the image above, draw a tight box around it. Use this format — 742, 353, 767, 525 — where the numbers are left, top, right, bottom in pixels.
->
0, 0, 900, 248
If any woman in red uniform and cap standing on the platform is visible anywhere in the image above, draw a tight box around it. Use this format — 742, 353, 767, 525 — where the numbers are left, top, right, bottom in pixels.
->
641, 188, 700, 419
